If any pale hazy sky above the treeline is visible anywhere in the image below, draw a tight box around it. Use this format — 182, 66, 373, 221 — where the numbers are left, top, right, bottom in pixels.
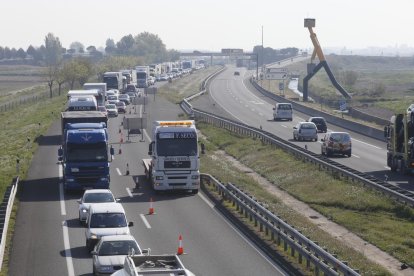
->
0, 0, 414, 51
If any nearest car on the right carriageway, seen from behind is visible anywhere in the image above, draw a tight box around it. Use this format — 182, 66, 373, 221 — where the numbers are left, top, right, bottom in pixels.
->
321, 131, 352, 157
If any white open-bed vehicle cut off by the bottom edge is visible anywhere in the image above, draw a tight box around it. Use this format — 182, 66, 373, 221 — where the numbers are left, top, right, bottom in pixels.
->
112, 254, 195, 276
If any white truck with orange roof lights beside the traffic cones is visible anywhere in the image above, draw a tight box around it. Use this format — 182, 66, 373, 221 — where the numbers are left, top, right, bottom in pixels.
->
142, 120, 200, 194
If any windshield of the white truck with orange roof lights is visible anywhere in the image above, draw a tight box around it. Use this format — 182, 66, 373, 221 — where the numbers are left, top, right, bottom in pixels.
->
157, 135, 197, 156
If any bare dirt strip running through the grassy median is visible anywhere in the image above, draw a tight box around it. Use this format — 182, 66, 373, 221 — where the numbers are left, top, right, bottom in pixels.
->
215, 151, 414, 276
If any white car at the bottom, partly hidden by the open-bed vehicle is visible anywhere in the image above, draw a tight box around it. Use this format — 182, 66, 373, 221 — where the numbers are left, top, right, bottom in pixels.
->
92, 235, 142, 275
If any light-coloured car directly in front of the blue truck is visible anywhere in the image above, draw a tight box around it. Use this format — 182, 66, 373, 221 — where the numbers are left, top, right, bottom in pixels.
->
78, 189, 119, 223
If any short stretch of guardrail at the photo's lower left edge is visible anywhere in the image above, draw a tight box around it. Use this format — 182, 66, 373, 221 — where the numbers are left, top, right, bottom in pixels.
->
0, 177, 19, 271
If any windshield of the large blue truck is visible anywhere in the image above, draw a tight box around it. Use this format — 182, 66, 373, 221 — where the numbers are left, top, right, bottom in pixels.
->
66, 142, 108, 162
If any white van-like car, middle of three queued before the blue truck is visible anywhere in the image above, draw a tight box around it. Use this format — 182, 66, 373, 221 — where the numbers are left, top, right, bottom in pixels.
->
85, 202, 134, 252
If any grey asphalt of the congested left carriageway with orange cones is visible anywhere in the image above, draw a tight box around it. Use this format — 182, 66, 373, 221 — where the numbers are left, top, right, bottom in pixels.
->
9, 78, 286, 275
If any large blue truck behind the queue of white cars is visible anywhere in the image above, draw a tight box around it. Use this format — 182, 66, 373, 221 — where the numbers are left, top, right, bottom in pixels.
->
58, 111, 114, 191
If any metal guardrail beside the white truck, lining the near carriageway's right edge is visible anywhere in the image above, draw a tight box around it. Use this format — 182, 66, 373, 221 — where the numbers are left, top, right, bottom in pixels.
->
201, 174, 359, 275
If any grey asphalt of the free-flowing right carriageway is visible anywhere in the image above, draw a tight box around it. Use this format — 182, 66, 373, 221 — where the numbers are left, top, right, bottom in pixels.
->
192, 64, 413, 190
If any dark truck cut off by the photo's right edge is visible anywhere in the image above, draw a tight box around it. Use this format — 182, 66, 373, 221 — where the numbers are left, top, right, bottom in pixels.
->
384, 112, 414, 174
